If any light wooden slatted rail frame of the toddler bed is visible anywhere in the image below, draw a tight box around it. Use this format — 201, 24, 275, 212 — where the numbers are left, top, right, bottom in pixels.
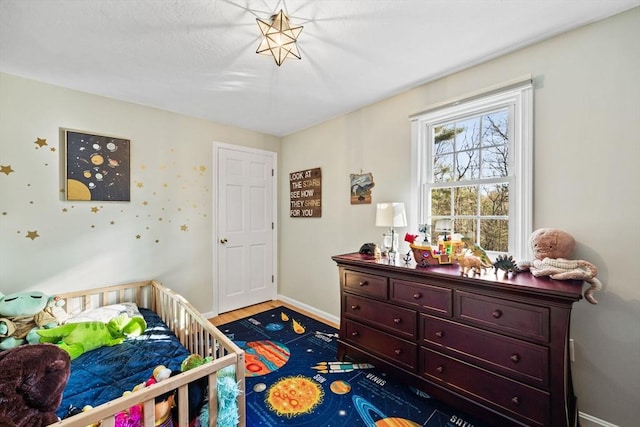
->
51, 280, 246, 427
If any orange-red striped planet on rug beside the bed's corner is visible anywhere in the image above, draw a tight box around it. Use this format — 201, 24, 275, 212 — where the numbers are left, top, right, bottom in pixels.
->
239, 340, 290, 377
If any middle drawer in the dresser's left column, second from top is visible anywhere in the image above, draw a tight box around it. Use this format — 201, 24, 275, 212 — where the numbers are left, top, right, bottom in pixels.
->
344, 294, 418, 340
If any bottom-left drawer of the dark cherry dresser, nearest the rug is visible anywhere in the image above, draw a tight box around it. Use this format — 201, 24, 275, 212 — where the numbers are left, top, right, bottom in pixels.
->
345, 320, 418, 372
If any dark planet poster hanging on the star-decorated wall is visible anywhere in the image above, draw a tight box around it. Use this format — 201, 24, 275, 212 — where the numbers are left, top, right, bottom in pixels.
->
62, 129, 131, 202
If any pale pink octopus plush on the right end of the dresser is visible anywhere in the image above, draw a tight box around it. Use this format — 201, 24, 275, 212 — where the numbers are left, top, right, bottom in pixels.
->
518, 228, 602, 304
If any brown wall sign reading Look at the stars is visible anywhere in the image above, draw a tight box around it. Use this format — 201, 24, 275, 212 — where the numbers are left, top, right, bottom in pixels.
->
289, 168, 322, 218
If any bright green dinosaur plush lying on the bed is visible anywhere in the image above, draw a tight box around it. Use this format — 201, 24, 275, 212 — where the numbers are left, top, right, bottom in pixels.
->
36, 313, 147, 360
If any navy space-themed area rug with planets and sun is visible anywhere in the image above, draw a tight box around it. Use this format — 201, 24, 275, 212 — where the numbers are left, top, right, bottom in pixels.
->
218, 307, 484, 427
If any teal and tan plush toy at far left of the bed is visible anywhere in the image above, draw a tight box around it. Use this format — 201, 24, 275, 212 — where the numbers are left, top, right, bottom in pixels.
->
0, 291, 64, 350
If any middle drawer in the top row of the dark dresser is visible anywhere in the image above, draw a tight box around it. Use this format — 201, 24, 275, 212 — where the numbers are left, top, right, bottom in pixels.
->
390, 279, 453, 317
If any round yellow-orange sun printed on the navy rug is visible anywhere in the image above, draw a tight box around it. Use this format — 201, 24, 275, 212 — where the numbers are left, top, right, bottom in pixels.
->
264, 375, 324, 418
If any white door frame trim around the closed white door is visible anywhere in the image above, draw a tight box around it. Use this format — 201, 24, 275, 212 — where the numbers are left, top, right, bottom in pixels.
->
211, 141, 278, 317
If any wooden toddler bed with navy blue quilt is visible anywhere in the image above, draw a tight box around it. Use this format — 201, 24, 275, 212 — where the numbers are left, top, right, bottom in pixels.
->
47, 280, 245, 427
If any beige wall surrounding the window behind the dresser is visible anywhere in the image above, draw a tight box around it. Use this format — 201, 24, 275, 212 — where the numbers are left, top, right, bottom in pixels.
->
279, 8, 640, 427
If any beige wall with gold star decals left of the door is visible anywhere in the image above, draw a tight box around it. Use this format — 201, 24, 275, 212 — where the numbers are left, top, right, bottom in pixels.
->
0, 74, 280, 312
